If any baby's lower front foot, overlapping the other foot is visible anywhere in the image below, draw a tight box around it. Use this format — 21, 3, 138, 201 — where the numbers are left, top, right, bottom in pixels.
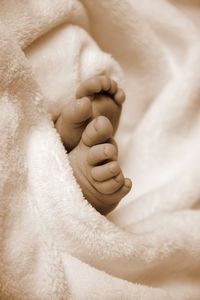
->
69, 116, 132, 214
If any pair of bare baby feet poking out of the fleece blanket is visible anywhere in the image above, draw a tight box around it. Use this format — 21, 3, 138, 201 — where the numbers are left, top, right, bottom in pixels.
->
55, 76, 132, 214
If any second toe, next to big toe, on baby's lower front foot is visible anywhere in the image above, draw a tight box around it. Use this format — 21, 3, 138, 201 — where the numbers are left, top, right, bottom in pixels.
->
88, 143, 118, 166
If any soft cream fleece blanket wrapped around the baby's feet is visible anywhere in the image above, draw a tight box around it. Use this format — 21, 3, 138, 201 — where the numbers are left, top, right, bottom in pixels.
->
0, 0, 200, 300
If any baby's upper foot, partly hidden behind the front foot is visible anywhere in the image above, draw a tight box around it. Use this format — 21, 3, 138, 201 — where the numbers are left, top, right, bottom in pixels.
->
55, 75, 125, 152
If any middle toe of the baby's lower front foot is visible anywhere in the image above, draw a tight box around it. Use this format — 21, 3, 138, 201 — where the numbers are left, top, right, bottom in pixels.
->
91, 161, 121, 182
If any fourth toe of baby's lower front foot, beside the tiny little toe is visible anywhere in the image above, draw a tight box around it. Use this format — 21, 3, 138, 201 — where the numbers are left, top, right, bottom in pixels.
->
94, 172, 124, 195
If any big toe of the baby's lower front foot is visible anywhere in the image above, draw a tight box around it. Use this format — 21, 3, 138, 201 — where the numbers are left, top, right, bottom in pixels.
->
82, 116, 113, 147
